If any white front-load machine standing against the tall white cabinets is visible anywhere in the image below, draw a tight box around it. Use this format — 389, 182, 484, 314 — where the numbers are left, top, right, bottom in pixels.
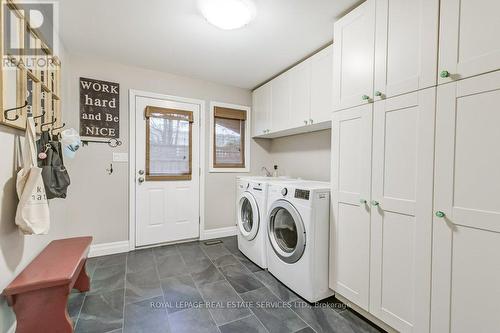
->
267, 181, 333, 303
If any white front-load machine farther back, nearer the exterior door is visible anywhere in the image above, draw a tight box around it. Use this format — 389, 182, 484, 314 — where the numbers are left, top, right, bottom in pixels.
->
236, 177, 296, 268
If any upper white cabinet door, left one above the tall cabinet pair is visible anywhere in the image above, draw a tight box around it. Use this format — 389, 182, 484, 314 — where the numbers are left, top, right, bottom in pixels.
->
333, 0, 375, 110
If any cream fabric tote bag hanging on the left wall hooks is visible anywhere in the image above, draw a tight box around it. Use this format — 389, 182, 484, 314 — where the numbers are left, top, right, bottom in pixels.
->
16, 117, 50, 235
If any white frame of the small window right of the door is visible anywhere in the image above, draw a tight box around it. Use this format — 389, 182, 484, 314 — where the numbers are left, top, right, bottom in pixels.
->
209, 101, 251, 173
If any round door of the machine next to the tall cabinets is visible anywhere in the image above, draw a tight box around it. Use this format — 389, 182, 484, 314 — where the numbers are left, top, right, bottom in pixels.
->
268, 200, 306, 264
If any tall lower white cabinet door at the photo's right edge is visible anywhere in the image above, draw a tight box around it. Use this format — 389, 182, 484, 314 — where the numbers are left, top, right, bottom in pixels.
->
431, 70, 500, 333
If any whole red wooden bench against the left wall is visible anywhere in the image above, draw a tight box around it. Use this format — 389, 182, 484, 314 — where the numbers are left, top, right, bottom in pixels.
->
3, 237, 92, 333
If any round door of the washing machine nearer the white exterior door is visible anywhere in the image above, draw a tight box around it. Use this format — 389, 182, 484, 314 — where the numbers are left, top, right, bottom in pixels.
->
238, 192, 260, 240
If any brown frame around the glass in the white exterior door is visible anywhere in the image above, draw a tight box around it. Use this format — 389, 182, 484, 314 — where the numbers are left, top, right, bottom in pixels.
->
145, 106, 194, 181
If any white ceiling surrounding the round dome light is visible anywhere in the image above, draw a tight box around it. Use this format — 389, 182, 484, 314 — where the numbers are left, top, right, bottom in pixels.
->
59, 0, 359, 88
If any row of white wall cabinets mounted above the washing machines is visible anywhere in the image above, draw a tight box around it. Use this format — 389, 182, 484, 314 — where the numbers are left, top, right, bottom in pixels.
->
253, 46, 333, 138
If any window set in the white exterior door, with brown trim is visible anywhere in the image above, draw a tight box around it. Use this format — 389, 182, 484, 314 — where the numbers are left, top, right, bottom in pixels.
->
146, 106, 193, 181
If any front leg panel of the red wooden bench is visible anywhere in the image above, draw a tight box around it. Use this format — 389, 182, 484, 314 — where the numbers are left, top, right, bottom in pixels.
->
13, 286, 73, 333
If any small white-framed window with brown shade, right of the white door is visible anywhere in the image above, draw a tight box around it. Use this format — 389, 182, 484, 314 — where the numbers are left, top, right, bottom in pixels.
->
210, 103, 250, 172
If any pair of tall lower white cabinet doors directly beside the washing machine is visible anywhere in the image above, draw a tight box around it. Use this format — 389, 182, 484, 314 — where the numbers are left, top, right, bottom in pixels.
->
330, 88, 435, 333
